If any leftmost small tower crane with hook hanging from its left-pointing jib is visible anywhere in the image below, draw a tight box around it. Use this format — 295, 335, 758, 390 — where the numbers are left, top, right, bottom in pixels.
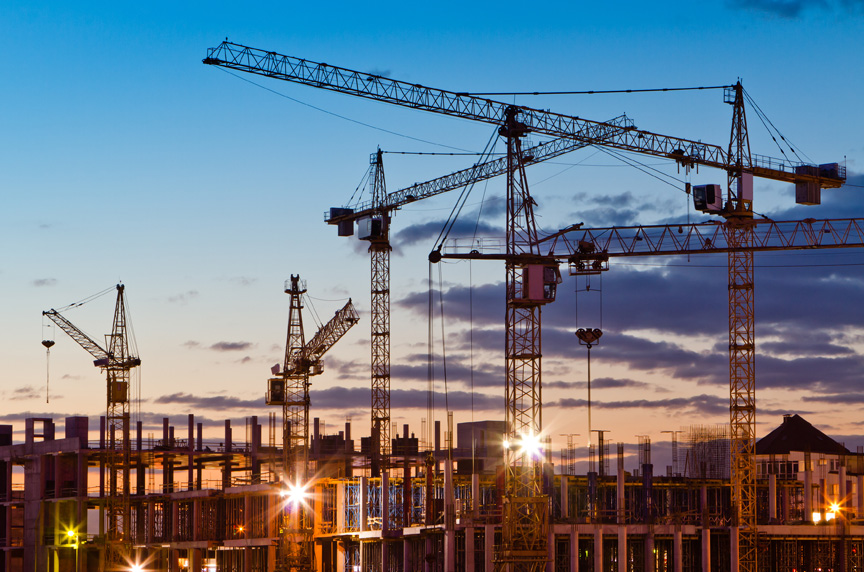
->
42, 284, 141, 570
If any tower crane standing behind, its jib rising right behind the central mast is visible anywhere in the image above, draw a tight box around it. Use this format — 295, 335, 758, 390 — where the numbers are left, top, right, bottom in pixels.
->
325, 119, 633, 476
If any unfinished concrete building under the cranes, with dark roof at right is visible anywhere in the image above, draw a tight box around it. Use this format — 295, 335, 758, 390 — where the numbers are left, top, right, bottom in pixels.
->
0, 415, 864, 572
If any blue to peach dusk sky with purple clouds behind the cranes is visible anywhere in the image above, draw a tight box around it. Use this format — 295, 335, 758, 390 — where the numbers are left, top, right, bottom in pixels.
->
0, 0, 864, 474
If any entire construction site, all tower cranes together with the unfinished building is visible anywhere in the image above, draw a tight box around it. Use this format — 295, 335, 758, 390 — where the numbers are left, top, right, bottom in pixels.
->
6, 40, 864, 572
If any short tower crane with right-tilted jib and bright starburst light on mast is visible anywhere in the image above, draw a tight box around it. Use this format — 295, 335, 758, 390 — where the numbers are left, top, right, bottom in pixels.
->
266, 274, 359, 572
